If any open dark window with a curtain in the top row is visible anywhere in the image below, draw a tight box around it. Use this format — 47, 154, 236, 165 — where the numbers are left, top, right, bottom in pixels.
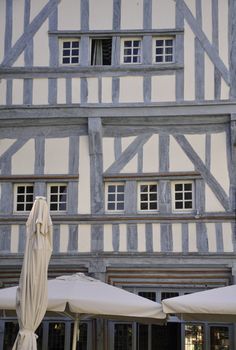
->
91, 38, 112, 66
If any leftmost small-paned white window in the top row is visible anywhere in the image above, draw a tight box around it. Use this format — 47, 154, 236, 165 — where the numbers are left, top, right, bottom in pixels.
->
61, 38, 79, 65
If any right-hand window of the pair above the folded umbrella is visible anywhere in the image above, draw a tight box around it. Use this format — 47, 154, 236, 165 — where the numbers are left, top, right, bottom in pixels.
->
48, 184, 67, 212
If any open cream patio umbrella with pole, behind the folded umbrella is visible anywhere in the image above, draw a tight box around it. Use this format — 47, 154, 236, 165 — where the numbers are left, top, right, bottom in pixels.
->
0, 273, 166, 349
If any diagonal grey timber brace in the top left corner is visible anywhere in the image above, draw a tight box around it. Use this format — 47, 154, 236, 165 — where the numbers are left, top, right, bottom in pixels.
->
1, 0, 60, 66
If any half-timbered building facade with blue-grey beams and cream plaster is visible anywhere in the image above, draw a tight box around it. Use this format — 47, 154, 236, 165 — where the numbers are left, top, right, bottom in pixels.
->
0, 0, 236, 350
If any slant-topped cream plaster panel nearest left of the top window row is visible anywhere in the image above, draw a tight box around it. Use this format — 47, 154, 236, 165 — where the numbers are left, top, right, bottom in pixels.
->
34, 21, 49, 67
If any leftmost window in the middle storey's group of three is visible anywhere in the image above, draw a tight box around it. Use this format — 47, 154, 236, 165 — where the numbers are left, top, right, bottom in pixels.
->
105, 182, 125, 211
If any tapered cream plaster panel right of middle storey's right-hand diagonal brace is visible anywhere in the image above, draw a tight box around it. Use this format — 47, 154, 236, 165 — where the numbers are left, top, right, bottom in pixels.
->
210, 133, 230, 194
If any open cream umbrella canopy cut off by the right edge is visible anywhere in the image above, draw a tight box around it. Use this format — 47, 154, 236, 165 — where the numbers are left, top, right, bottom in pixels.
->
162, 285, 236, 322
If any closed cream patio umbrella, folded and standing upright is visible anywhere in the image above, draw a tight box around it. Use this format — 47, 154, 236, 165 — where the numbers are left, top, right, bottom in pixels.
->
13, 197, 52, 350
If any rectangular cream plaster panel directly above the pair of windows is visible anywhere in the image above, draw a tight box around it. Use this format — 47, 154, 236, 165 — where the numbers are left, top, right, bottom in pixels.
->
44, 137, 69, 174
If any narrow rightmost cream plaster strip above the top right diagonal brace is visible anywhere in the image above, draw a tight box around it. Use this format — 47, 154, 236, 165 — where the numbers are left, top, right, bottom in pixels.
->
218, 0, 229, 67
